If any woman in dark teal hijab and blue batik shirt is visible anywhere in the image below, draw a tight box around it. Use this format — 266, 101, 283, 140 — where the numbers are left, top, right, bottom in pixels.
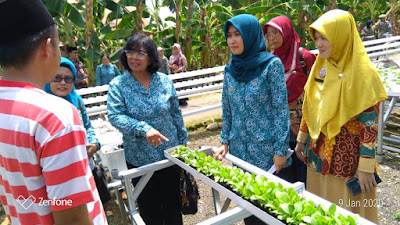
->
214, 14, 291, 224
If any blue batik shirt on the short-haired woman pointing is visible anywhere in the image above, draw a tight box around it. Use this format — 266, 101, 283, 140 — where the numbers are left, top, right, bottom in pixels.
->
107, 71, 187, 166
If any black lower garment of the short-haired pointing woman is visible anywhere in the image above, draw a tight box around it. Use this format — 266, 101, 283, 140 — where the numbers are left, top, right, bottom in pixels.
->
126, 162, 183, 225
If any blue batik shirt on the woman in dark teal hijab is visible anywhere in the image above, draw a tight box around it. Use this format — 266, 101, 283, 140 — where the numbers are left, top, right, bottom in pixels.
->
221, 58, 291, 170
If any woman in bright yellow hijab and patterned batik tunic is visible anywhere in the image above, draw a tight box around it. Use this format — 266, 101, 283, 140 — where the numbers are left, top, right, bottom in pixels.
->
296, 9, 387, 222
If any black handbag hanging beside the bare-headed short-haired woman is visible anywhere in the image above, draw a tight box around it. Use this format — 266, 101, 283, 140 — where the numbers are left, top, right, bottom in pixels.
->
180, 169, 200, 215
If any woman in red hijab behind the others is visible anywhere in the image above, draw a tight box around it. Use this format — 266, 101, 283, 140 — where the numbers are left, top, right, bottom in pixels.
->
263, 16, 316, 184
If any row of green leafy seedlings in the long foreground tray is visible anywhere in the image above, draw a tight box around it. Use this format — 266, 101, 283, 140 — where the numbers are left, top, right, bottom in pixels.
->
171, 146, 358, 225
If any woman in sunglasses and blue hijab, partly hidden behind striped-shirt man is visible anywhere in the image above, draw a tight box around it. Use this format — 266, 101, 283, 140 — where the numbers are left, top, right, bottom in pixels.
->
44, 57, 111, 203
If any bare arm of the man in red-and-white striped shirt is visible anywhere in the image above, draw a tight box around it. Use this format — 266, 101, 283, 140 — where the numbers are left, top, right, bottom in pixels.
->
53, 204, 93, 225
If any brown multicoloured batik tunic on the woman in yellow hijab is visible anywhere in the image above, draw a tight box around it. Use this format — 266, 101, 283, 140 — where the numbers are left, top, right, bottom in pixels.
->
300, 103, 379, 178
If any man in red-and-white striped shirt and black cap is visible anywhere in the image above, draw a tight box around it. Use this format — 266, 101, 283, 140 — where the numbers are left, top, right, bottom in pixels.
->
0, 0, 107, 224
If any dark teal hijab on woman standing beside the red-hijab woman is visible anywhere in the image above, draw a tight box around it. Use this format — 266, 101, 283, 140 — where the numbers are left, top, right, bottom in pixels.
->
224, 14, 276, 83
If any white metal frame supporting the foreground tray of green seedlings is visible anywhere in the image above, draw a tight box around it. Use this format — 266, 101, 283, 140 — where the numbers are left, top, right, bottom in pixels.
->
111, 147, 374, 225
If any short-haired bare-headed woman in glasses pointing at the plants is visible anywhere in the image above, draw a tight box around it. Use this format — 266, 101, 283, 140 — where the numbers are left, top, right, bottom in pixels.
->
107, 34, 187, 225
